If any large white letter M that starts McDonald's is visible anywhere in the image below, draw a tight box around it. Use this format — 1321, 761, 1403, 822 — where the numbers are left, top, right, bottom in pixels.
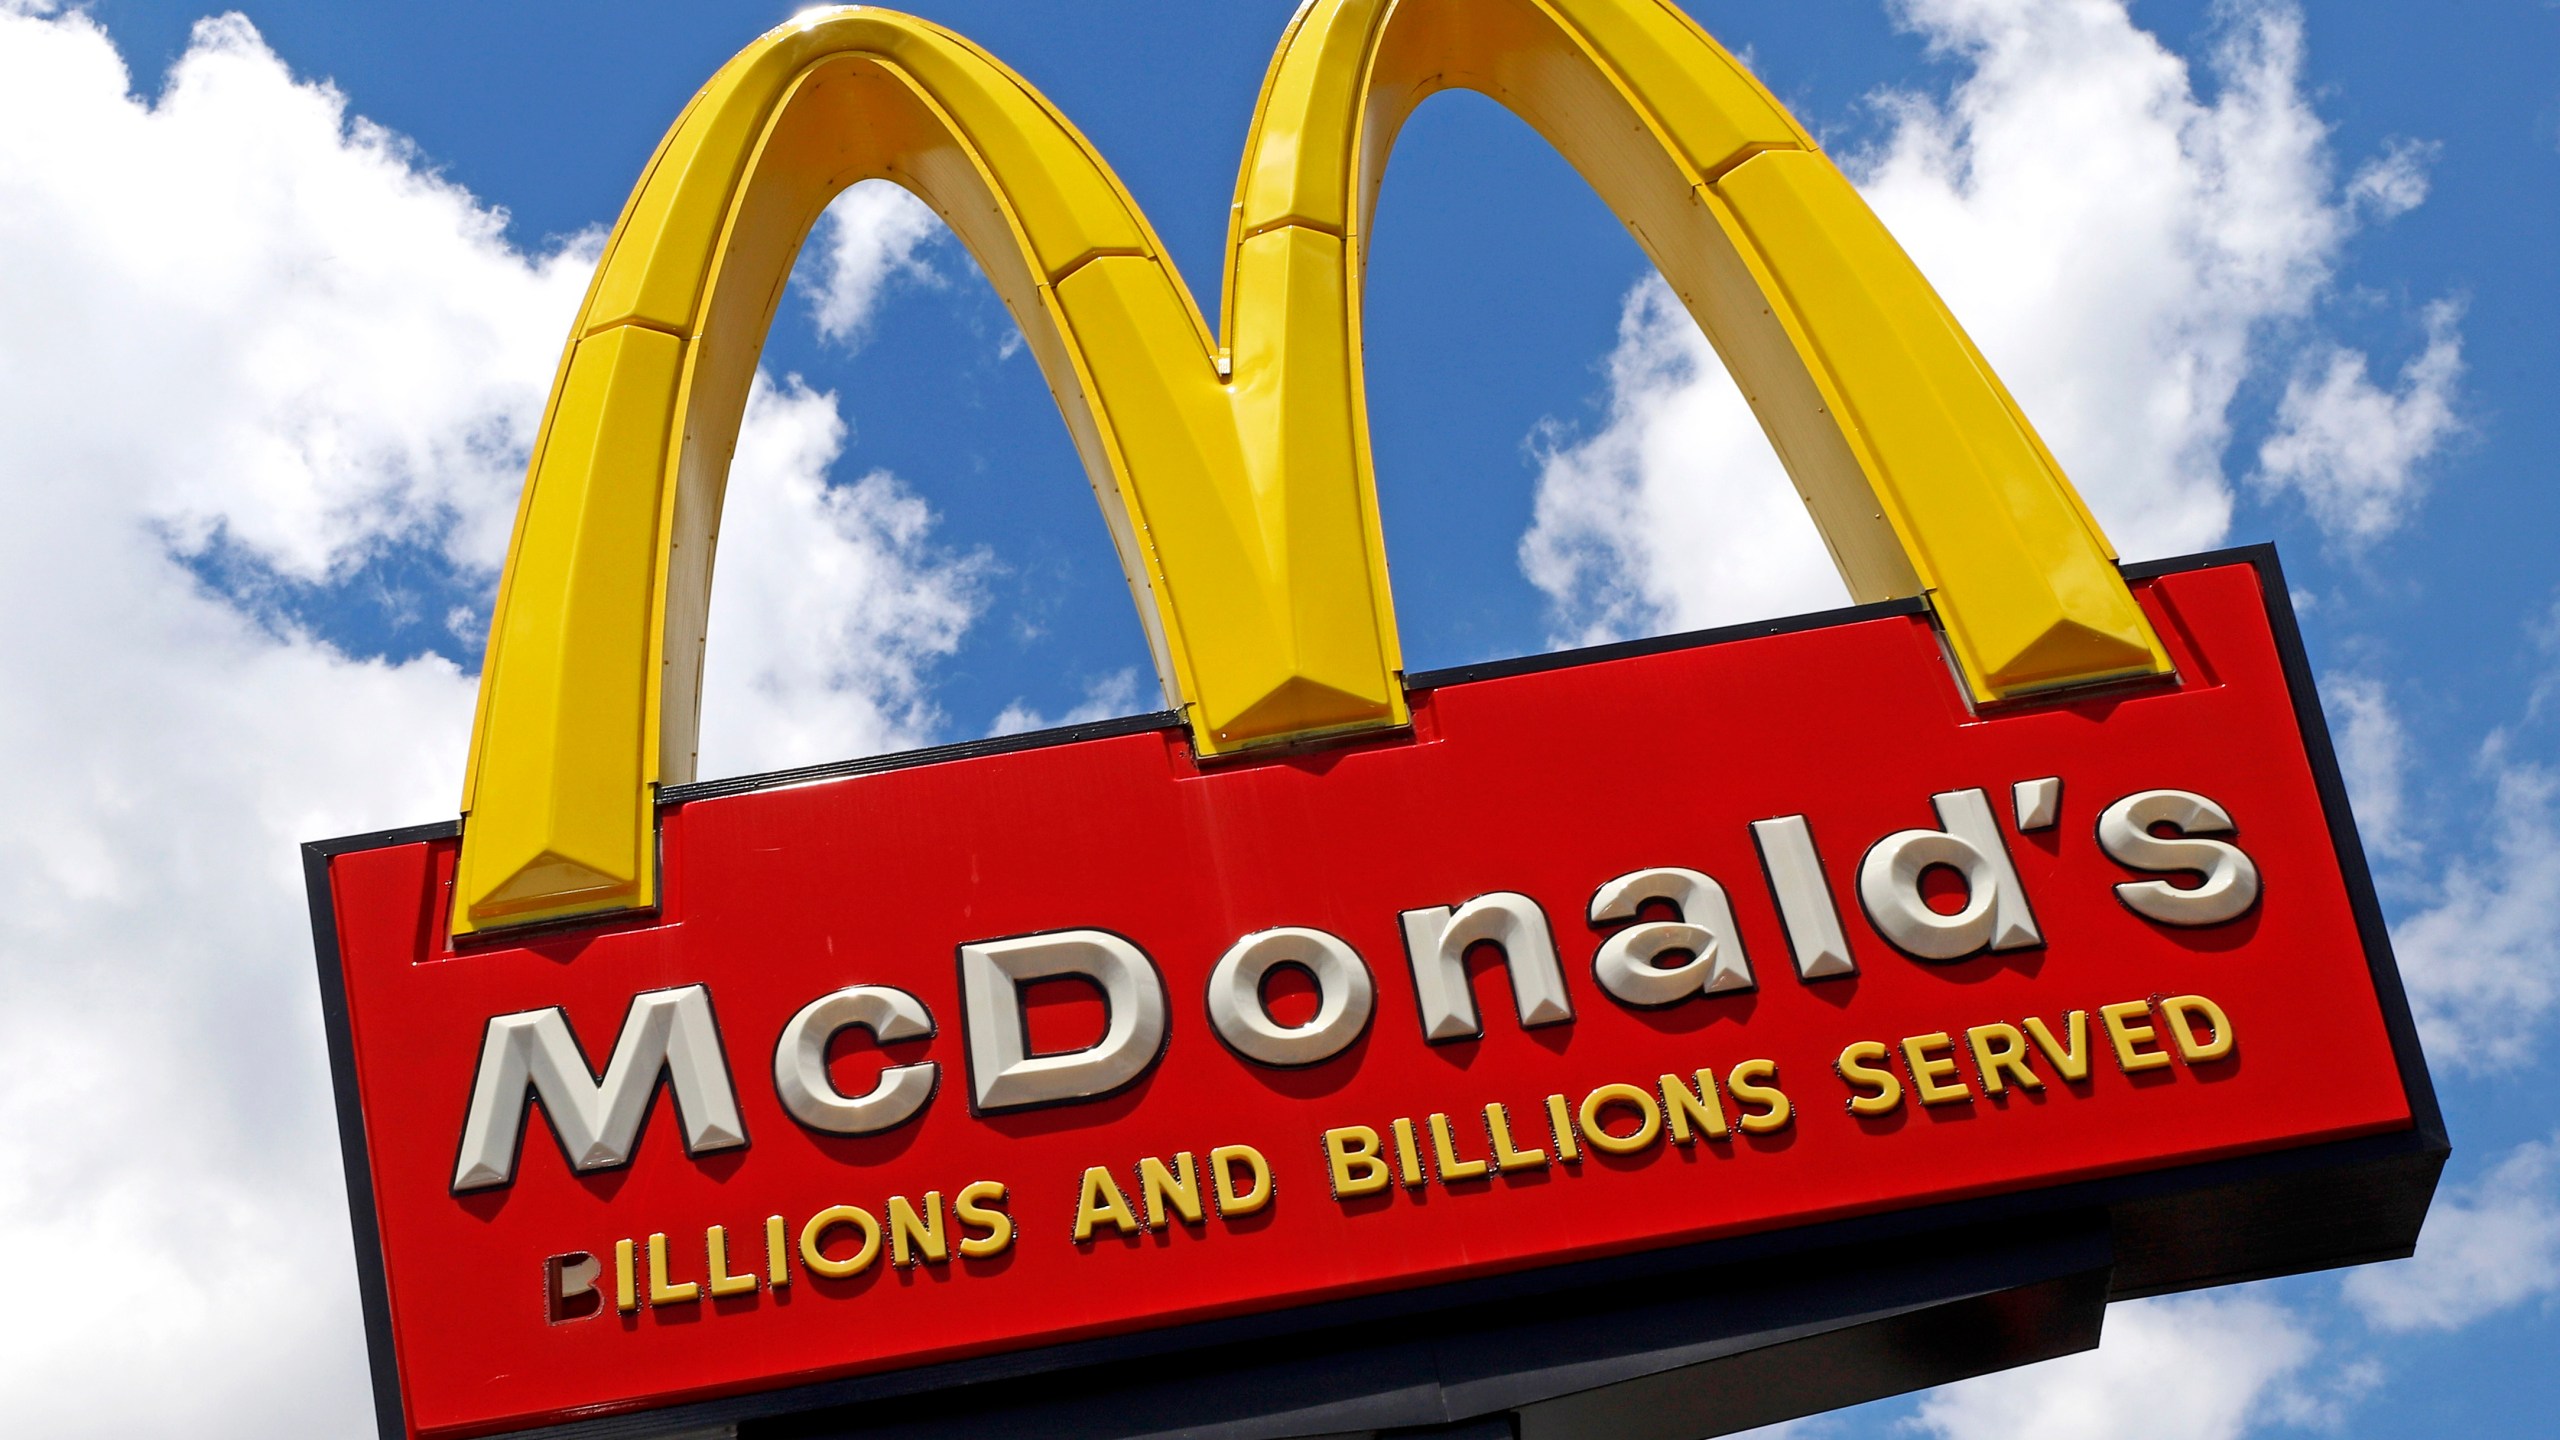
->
453, 984, 748, 1194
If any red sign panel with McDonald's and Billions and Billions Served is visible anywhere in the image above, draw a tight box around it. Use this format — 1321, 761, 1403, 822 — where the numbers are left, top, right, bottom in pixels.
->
315, 548, 2429, 1435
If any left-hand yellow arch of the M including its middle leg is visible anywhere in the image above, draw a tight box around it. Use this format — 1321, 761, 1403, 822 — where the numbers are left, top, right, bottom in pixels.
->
453, 10, 1405, 933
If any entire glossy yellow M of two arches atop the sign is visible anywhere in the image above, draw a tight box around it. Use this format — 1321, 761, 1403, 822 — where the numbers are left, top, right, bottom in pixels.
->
453, 0, 2168, 933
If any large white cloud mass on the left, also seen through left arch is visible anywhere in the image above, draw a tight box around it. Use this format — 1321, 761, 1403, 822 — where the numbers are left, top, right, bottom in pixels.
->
0, 3, 973, 1437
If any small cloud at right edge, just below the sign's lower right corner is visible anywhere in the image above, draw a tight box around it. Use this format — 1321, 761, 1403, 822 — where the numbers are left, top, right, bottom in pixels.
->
2345, 1138, 2560, 1335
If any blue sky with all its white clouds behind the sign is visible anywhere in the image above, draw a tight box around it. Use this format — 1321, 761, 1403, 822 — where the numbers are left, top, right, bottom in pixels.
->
0, 0, 2560, 1440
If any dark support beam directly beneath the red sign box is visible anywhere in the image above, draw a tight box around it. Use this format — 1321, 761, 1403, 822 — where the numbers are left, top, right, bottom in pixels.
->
773, 1215, 2109, 1440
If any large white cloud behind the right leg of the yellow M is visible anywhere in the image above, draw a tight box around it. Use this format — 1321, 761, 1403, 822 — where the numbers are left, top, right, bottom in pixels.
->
1521, 0, 2460, 641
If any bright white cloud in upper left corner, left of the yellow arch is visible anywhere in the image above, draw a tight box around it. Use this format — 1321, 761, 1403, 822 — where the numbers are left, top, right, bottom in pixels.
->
0, 15, 594, 579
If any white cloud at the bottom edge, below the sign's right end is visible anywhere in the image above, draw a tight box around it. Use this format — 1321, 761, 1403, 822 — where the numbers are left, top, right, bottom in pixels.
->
1912, 1294, 2324, 1440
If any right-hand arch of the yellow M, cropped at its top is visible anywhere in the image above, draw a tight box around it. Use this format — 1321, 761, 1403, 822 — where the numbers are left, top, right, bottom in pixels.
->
1229, 0, 2168, 702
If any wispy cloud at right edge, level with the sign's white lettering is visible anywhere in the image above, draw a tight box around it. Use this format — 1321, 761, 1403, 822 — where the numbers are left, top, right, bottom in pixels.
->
2391, 753, 2560, 1071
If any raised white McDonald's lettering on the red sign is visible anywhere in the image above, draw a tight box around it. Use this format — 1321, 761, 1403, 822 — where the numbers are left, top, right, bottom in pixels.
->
453, 776, 2260, 1194
